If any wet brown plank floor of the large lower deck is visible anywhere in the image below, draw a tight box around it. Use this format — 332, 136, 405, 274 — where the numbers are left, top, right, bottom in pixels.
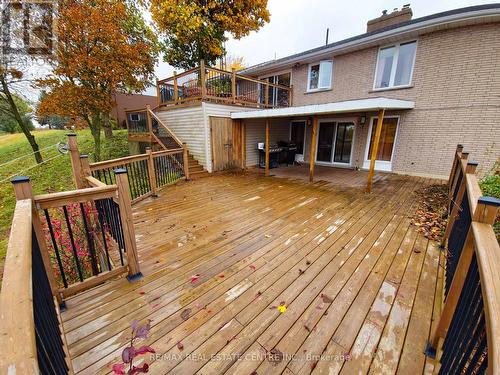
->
59, 173, 442, 375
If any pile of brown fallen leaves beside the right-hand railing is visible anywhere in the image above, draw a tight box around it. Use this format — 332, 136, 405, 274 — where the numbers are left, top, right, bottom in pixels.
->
411, 185, 450, 241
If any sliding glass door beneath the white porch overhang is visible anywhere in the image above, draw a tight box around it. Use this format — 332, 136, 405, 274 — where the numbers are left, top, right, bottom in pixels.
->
316, 121, 354, 166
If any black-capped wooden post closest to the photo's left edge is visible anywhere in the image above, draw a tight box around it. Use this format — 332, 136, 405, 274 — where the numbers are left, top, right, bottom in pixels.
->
10, 176, 65, 310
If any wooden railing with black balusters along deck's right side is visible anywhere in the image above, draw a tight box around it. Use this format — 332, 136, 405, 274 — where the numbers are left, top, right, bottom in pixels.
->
429, 145, 500, 374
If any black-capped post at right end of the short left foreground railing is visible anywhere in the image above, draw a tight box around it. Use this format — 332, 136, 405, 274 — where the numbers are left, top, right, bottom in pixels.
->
114, 168, 142, 281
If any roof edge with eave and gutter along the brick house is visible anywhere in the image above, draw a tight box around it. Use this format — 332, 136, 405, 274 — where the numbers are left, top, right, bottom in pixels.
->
239, 3, 500, 74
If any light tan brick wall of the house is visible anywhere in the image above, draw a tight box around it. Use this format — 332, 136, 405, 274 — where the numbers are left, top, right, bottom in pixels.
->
286, 23, 500, 177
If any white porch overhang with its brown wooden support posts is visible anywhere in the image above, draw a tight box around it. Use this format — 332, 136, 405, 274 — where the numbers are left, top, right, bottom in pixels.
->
231, 97, 415, 192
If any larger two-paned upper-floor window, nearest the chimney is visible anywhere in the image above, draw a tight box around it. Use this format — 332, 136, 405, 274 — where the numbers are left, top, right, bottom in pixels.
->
375, 41, 417, 89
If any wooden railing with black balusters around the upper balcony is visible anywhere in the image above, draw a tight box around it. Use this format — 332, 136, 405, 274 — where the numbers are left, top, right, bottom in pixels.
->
156, 61, 292, 108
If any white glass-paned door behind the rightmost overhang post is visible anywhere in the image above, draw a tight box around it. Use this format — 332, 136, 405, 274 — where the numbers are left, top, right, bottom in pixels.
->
363, 117, 399, 171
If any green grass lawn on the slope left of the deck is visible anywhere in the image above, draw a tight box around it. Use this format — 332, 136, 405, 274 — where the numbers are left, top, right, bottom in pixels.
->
0, 130, 128, 279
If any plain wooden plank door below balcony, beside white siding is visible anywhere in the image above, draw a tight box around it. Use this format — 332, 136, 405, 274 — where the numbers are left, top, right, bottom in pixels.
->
210, 117, 241, 172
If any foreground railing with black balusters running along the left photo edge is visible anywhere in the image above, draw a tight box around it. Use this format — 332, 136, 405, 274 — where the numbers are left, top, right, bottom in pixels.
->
0, 198, 72, 374
